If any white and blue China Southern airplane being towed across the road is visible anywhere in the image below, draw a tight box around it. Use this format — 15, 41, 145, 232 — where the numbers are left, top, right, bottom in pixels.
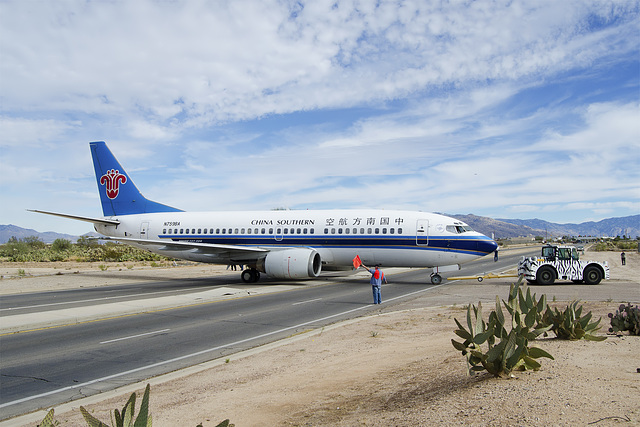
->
30, 141, 498, 285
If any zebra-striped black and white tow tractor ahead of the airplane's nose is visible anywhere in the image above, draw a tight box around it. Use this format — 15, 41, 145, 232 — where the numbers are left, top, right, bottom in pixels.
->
518, 245, 609, 285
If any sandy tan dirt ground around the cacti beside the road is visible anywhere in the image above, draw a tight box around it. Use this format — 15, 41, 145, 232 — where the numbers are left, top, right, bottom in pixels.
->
0, 252, 640, 427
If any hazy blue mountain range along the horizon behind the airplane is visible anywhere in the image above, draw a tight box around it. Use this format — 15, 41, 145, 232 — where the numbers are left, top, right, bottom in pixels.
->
0, 214, 640, 244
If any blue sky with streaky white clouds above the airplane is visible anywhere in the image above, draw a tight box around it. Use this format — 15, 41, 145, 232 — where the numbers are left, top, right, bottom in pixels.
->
0, 0, 640, 234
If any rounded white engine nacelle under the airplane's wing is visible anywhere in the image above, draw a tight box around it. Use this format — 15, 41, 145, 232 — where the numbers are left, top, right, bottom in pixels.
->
257, 248, 322, 279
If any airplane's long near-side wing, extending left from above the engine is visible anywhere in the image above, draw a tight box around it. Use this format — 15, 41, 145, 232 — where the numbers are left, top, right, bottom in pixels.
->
98, 237, 269, 261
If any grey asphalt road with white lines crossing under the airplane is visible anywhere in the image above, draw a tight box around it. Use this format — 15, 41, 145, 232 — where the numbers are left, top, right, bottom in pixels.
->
0, 249, 537, 419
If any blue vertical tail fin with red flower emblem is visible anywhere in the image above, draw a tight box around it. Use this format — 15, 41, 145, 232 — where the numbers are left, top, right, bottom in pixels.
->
89, 141, 181, 216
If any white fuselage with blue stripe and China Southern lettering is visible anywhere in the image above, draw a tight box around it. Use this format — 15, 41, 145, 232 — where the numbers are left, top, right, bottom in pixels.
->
96, 210, 497, 269
